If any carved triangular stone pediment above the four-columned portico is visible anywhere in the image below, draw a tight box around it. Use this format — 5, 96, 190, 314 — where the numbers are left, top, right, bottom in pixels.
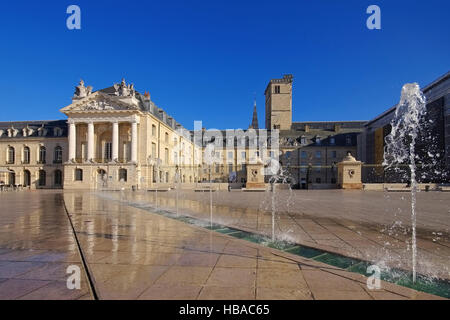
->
61, 91, 140, 113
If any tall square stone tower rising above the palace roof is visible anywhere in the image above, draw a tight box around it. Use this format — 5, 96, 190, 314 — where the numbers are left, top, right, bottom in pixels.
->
264, 74, 293, 130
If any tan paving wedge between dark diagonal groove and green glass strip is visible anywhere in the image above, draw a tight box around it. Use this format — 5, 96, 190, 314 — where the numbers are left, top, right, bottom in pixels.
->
61, 192, 439, 300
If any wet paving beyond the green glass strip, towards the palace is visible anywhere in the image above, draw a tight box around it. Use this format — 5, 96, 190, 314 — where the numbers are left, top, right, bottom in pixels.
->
108, 190, 450, 279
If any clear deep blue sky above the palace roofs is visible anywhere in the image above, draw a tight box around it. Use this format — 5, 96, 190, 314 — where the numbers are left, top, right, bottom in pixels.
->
0, 0, 450, 129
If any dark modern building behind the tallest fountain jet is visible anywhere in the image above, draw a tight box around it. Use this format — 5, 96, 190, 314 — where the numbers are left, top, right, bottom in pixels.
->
358, 72, 450, 183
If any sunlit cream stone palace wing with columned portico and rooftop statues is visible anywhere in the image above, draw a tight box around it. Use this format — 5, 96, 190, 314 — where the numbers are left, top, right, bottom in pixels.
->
61, 80, 201, 189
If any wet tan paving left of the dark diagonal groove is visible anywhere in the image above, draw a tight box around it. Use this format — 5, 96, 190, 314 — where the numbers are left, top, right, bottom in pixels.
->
0, 191, 92, 300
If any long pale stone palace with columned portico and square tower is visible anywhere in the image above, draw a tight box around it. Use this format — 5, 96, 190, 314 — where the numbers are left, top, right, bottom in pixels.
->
0, 73, 450, 190
